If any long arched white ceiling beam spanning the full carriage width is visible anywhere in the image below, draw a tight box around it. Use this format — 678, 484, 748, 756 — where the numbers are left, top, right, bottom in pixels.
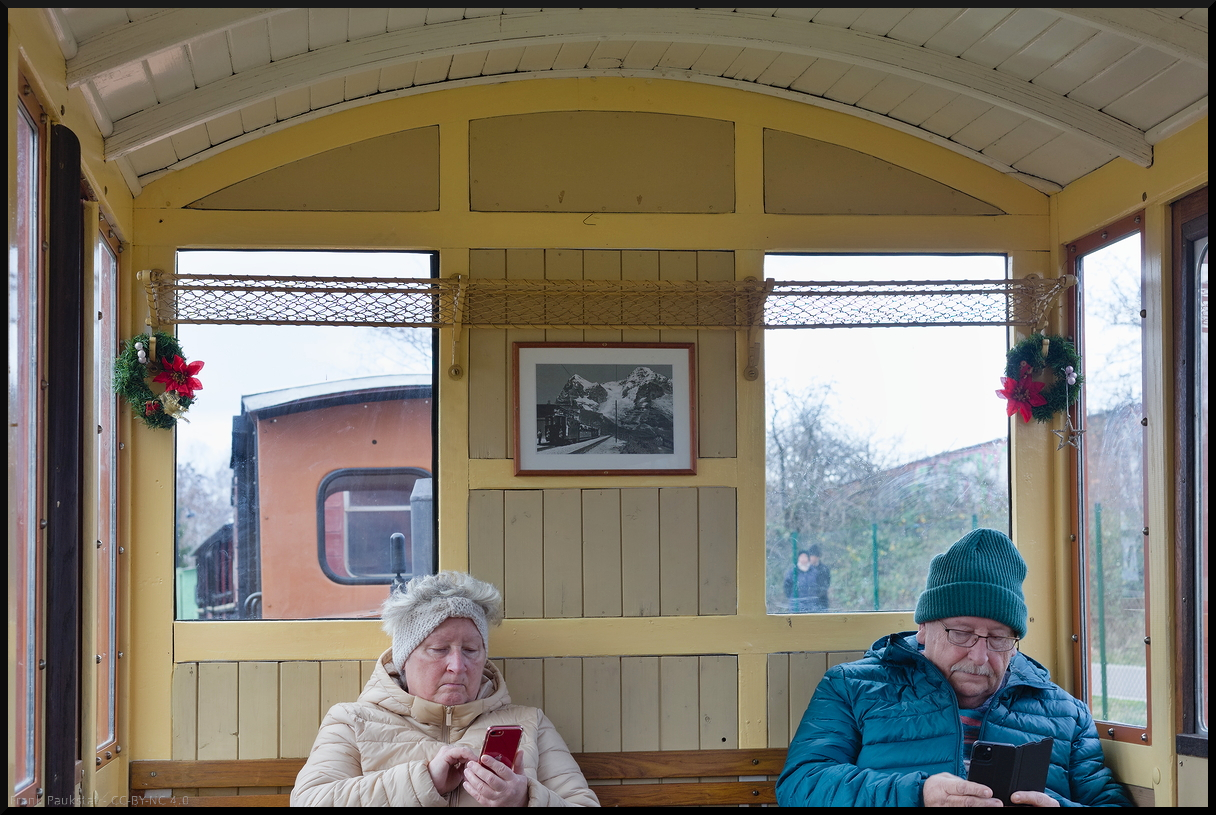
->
106, 9, 1153, 167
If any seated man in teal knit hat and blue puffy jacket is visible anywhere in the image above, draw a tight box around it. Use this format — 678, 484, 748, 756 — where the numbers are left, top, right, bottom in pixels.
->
777, 529, 1131, 806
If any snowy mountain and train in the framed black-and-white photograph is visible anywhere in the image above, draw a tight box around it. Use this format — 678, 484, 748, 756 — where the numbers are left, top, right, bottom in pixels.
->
537, 366, 675, 454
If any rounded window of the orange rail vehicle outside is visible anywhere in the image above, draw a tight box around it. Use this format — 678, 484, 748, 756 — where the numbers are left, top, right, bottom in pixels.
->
317, 468, 433, 585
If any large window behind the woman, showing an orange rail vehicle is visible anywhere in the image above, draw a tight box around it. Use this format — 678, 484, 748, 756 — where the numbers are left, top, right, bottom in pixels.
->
175, 251, 437, 619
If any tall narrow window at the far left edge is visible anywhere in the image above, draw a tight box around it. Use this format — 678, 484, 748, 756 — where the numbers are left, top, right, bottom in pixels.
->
9, 66, 46, 804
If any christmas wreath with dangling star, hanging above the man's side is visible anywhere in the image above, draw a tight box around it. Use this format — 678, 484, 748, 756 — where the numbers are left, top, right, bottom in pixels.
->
996, 333, 1085, 422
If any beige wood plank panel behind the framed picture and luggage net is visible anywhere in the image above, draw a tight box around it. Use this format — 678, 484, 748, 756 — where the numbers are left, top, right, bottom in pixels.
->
468, 249, 737, 459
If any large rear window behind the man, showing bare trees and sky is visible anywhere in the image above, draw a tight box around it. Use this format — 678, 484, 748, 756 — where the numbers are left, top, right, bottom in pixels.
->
765, 254, 1010, 614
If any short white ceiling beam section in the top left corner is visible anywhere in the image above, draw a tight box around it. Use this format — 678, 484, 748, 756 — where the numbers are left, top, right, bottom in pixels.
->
67, 9, 289, 88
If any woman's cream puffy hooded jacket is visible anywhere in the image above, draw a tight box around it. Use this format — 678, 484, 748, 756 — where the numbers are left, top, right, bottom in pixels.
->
292, 648, 599, 806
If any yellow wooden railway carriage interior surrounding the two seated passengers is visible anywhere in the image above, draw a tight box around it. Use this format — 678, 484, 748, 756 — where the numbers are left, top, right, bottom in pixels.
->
7, 7, 1209, 806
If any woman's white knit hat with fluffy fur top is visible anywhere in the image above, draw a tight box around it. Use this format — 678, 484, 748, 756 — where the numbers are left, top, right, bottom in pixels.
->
381, 572, 502, 670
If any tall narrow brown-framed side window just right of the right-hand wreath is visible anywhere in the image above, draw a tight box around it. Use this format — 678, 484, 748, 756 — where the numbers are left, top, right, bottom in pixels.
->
1068, 214, 1150, 743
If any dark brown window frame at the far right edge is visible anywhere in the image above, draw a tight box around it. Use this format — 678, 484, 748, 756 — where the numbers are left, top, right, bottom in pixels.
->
1171, 187, 1209, 758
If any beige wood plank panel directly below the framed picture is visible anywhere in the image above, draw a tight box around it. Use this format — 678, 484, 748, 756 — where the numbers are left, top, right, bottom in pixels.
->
468, 487, 737, 618
